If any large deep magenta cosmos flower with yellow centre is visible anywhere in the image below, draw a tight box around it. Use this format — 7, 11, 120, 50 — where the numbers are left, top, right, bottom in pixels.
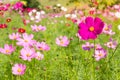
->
78, 17, 104, 40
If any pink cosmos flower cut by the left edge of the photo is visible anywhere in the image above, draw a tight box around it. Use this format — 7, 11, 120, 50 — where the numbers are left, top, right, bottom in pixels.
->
0, 44, 15, 54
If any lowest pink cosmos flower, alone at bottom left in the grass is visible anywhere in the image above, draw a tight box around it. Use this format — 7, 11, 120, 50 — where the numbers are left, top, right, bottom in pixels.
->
12, 64, 26, 75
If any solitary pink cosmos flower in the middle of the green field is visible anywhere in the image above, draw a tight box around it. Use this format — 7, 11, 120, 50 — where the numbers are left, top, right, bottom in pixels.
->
56, 36, 70, 47
